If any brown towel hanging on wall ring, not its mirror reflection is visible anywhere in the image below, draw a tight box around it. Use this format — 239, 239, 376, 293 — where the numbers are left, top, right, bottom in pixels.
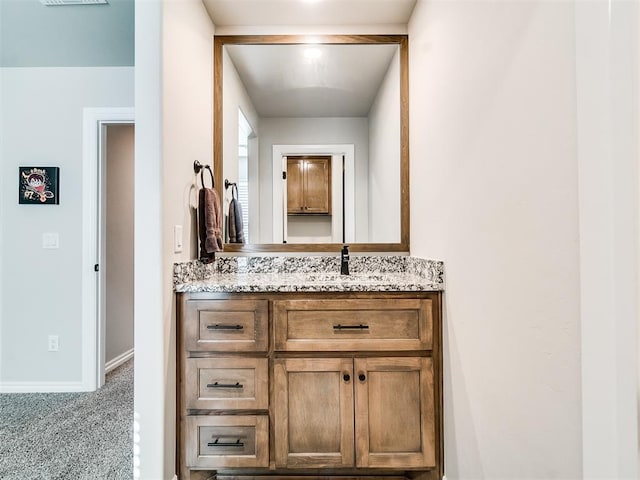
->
198, 188, 224, 261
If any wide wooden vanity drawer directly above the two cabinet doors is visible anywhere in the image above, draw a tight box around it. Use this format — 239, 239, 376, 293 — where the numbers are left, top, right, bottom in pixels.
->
273, 298, 433, 351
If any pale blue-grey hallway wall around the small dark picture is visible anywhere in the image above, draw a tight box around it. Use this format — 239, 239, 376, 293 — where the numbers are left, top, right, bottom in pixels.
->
0, 67, 134, 390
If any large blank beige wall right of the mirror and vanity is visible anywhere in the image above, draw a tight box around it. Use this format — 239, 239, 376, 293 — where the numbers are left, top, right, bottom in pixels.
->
409, 1, 582, 479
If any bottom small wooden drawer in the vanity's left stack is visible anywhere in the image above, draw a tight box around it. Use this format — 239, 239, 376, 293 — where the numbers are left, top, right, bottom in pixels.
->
186, 415, 269, 468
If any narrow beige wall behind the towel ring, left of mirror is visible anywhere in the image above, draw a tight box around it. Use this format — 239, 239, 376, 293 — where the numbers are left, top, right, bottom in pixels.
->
162, 0, 214, 480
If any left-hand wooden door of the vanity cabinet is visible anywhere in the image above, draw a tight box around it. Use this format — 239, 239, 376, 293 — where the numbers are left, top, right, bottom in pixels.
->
274, 358, 354, 468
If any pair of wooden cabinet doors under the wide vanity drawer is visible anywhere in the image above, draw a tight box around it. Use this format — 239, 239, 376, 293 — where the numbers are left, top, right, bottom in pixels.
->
274, 357, 435, 468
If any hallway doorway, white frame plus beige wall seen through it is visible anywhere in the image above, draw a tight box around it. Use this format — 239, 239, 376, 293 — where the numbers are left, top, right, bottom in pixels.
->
82, 108, 135, 391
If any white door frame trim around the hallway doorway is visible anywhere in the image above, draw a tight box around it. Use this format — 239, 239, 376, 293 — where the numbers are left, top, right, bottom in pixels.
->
81, 108, 135, 391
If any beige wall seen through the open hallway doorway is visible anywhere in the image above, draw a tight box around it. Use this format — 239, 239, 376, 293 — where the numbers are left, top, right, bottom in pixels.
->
105, 125, 134, 363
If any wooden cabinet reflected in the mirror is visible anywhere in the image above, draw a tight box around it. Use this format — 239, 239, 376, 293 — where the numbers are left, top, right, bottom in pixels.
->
287, 156, 331, 215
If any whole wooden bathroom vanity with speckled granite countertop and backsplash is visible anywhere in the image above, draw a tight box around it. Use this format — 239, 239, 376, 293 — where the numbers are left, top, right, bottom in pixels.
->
174, 257, 444, 480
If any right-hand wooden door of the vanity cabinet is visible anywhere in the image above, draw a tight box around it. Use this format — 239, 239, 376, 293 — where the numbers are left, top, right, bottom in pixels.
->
354, 357, 435, 468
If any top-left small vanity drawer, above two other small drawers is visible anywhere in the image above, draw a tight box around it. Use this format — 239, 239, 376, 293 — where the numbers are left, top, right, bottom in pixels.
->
183, 300, 269, 352
